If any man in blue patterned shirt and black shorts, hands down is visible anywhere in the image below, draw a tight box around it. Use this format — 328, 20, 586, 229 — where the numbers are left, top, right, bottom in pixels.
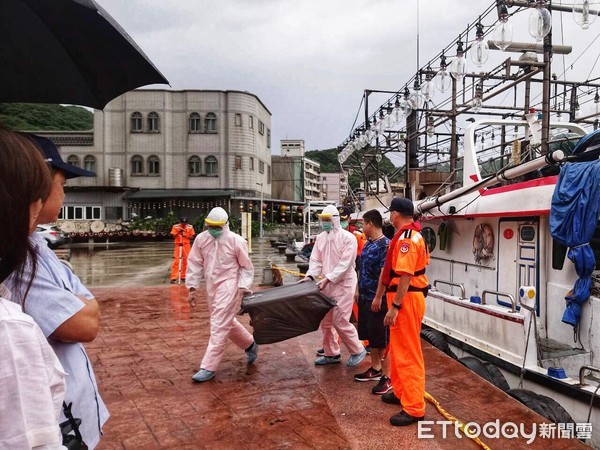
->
354, 209, 392, 395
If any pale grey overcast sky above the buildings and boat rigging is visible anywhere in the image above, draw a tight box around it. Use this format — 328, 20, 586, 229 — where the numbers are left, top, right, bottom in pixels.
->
97, 0, 600, 154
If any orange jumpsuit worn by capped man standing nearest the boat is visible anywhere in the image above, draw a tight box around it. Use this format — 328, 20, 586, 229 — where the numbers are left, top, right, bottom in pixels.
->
384, 222, 429, 417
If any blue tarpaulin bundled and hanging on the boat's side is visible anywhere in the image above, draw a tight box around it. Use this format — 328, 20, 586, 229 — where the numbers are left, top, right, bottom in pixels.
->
550, 133, 600, 327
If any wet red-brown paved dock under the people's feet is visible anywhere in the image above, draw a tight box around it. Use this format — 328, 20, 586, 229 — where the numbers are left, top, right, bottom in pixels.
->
86, 280, 585, 450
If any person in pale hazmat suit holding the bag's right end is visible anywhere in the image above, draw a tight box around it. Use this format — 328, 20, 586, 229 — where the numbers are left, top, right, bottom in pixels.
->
300, 205, 367, 367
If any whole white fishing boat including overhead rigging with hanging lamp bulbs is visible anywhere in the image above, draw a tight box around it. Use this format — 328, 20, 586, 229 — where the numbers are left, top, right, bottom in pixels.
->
338, 0, 600, 442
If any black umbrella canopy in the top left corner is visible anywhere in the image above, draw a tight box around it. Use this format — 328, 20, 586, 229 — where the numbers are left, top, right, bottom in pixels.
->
0, 0, 168, 109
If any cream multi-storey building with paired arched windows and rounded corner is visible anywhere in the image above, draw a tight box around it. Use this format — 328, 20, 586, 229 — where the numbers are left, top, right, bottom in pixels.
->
56, 89, 271, 220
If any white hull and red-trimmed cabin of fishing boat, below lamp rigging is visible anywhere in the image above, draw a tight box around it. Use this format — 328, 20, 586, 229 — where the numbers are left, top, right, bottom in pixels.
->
415, 114, 600, 448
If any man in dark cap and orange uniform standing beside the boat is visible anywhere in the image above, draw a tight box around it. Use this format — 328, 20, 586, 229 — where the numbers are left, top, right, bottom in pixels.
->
376, 197, 429, 426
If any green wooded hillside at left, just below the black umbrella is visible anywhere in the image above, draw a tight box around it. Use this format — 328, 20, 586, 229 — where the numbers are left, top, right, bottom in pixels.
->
0, 103, 94, 131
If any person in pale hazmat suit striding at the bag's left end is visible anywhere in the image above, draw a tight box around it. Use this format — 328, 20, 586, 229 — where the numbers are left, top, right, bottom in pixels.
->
185, 208, 258, 382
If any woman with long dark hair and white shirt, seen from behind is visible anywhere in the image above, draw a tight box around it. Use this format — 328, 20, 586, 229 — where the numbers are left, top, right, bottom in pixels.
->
0, 129, 65, 450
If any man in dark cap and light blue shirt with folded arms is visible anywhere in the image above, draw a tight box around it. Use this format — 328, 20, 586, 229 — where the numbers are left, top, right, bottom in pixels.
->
5, 135, 109, 450
